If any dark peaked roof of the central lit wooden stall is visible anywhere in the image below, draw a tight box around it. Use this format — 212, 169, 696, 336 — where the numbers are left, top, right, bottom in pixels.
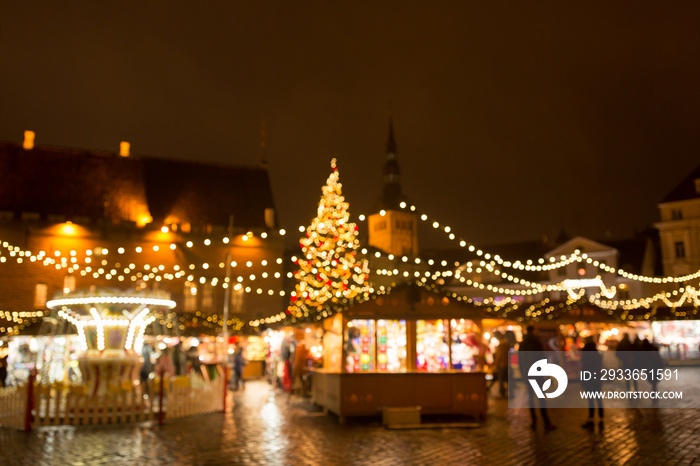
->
343, 284, 493, 320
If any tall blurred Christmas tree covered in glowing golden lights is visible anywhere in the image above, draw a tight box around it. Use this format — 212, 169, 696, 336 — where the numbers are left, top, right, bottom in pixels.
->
288, 159, 369, 318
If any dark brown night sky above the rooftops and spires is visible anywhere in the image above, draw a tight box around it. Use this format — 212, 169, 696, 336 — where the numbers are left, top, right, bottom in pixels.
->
0, 0, 700, 248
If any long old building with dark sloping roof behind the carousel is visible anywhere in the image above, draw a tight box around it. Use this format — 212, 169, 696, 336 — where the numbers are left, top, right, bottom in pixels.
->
0, 138, 283, 332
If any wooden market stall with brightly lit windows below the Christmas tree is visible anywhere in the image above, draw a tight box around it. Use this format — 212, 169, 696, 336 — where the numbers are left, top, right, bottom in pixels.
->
312, 285, 488, 422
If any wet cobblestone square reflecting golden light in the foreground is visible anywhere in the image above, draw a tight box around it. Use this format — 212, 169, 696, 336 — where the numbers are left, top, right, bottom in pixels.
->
0, 381, 700, 466
